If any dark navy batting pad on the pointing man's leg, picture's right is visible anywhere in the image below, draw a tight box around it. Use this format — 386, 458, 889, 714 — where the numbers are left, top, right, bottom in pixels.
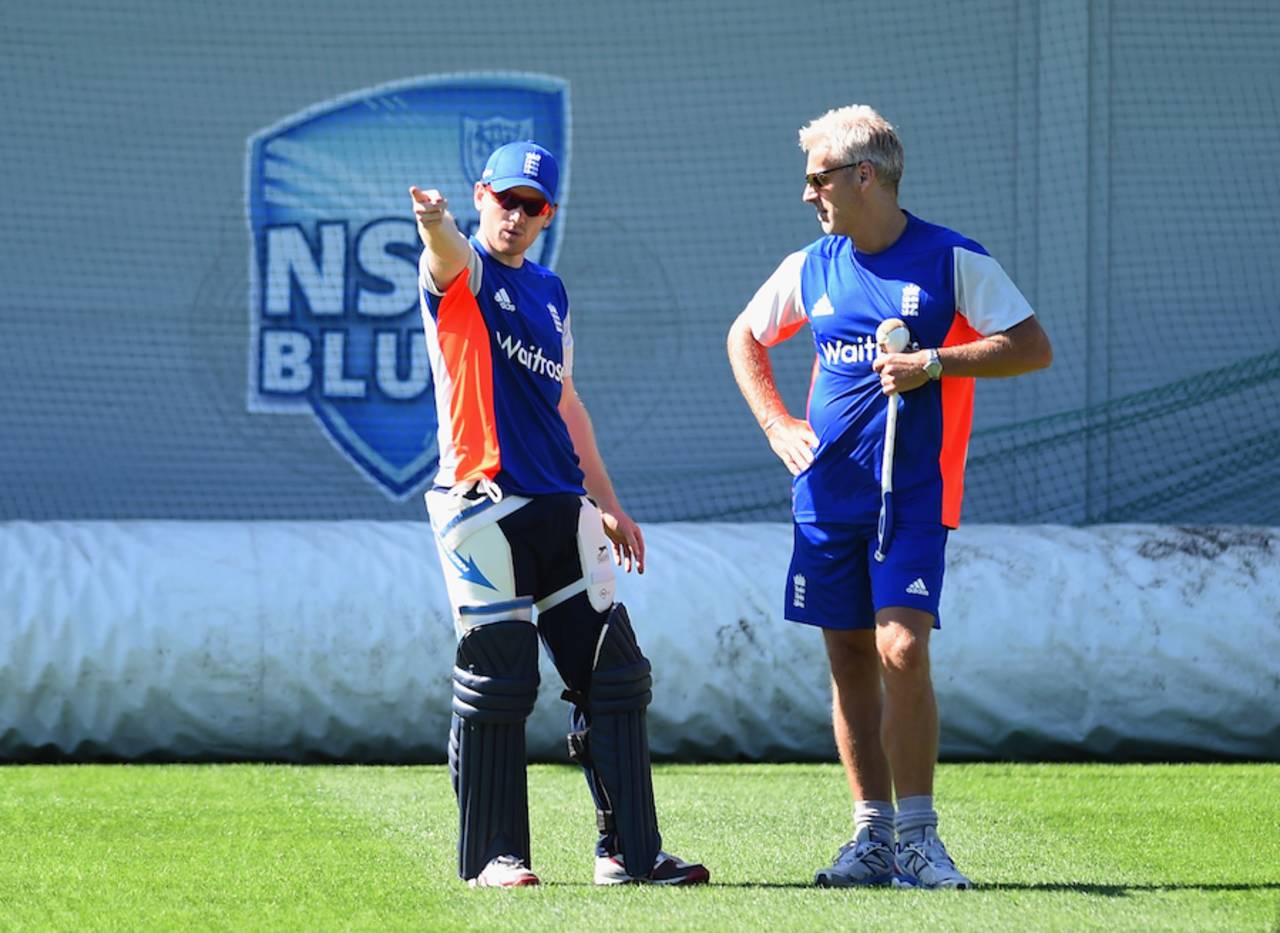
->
570, 603, 662, 877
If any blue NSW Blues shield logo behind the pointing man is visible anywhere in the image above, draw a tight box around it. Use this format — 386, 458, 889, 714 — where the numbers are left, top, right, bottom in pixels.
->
247, 74, 570, 499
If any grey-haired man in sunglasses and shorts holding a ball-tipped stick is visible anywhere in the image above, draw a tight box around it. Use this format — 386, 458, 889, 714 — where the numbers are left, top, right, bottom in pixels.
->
728, 106, 1052, 888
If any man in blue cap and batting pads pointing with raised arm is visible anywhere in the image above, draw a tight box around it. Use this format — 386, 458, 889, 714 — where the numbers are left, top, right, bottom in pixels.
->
410, 141, 709, 887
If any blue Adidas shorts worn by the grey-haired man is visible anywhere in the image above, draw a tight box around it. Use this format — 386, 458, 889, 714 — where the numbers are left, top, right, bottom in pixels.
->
783, 522, 947, 628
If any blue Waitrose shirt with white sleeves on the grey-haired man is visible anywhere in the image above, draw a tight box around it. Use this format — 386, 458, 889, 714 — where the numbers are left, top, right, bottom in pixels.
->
746, 211, 1032, 527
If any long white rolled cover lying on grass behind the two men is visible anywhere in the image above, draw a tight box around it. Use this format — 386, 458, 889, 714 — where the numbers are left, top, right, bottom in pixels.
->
0, 521, 1280, 762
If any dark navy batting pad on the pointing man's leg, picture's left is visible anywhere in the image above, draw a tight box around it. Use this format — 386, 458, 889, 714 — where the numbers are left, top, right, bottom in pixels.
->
449, 622, 538, 879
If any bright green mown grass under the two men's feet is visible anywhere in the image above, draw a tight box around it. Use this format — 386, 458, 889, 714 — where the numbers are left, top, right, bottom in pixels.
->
0, 765, 1280, 930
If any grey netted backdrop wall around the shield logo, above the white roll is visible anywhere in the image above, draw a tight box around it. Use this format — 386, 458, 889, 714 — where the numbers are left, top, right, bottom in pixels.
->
0, 0, 1280, 523
